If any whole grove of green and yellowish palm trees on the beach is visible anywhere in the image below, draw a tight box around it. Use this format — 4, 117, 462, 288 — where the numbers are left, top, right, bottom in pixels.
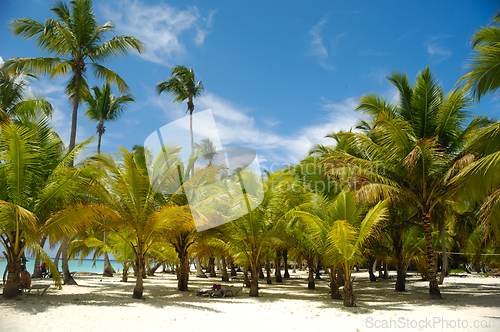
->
0, 0, 500, 306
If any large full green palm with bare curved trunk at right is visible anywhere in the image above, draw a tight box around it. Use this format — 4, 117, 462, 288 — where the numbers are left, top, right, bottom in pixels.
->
325, 68, 487, 297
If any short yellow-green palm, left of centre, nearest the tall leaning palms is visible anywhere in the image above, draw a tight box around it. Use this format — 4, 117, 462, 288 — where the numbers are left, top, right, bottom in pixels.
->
86, 148, 192, 299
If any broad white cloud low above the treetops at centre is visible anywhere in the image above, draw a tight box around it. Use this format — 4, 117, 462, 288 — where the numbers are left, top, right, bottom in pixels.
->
158, 93, 360, 164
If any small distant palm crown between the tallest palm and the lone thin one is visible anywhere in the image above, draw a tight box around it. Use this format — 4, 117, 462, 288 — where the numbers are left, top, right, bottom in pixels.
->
85, 83, 135, 154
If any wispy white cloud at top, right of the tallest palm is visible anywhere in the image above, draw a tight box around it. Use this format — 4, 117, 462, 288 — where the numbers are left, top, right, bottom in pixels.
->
101, 0, 216, 66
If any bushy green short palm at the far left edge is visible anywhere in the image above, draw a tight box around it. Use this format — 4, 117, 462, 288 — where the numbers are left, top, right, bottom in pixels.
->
0, 120, 96, 298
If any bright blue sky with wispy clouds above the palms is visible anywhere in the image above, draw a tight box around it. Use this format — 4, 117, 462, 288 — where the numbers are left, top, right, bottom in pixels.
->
0, 0, 500, 169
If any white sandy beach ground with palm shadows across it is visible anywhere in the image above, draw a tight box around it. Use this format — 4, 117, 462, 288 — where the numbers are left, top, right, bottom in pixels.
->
0, 272, 500, 331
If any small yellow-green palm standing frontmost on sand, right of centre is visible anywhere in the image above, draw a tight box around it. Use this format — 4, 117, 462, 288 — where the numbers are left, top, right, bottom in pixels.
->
294, 191, 387, 307
